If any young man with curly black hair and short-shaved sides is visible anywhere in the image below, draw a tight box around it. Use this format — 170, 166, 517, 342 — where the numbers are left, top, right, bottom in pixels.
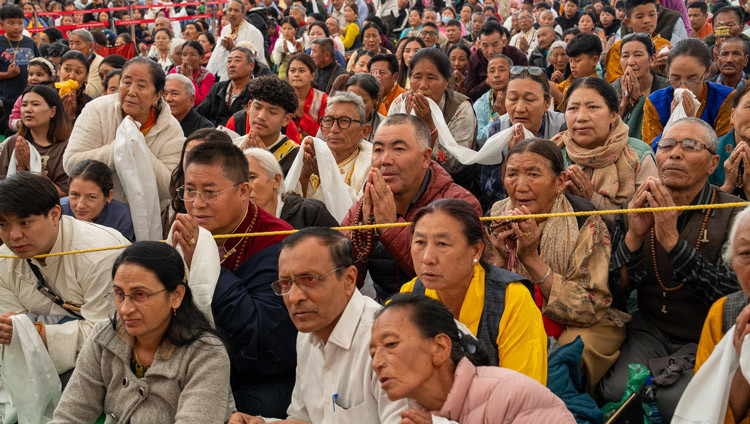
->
227, 75, 299, 176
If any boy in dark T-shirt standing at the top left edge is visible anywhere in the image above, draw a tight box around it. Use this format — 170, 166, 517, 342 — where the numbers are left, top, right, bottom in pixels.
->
0, 3, 40, 135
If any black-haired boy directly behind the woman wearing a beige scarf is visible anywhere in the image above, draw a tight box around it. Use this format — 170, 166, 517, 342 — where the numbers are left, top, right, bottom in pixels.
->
550, 34, 602, 110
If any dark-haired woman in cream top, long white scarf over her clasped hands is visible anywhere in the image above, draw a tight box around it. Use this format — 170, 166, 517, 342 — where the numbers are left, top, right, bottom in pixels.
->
388, 45, 478, 191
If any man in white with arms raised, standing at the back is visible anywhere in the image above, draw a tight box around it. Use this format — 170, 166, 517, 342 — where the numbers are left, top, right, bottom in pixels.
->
206, 0, 268, 81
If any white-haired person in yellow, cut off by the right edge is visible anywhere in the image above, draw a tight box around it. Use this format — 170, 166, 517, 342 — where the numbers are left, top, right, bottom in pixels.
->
692, 207, 750, 424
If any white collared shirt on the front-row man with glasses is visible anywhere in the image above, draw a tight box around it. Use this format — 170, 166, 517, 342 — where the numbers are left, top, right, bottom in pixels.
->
270, 290, 409, 424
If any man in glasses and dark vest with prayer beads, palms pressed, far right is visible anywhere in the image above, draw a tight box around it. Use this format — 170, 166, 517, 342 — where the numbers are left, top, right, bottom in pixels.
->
599, 118, 741, 422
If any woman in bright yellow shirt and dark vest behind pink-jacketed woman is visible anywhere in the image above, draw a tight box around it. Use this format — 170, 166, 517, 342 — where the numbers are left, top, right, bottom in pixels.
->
401, 199, 547, 384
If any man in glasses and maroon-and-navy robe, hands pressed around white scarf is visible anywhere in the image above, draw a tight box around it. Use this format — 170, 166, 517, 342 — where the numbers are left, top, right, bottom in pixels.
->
171, 141, 296, 416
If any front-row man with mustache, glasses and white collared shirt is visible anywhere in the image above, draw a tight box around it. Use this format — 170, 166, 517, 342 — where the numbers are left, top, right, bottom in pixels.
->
229, 227, 408, 424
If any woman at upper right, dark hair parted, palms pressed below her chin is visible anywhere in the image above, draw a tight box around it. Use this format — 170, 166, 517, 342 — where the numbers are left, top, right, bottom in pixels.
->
612, 33, 669, 138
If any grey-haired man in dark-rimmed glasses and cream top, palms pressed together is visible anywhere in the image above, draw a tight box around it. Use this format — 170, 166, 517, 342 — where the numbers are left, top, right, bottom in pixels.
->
299, 91, 372, 202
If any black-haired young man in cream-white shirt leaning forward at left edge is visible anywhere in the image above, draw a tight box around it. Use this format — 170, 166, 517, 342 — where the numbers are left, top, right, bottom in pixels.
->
0, 172, 130, 387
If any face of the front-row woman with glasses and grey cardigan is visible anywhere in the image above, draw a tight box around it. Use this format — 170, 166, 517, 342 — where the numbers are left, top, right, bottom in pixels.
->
112, 263, 185, 338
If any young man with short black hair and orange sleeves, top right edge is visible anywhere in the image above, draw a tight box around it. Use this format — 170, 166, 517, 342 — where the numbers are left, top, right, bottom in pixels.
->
605, 0, 671, 84
